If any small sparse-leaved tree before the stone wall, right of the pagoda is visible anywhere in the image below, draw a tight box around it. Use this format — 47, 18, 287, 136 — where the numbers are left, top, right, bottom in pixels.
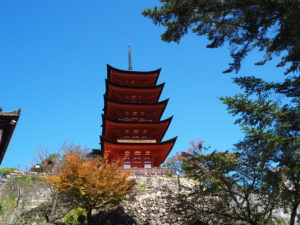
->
177, 145, 279, 225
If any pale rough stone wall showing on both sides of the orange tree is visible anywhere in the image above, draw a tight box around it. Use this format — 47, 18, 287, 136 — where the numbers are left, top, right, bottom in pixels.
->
0, 174, 192, 225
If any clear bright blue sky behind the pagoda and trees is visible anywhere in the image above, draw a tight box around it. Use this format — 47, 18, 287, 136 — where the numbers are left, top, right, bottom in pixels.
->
0, 0, 283, 169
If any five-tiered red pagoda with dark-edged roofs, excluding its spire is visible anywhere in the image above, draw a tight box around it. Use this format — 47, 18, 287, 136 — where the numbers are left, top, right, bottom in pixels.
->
101, 65, 176, 168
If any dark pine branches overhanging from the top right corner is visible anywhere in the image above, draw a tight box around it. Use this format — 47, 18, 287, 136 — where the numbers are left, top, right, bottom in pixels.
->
143, 0, 300, 73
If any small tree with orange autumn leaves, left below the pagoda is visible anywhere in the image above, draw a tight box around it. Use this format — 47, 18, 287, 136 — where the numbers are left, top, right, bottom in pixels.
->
45, 151, 134, 223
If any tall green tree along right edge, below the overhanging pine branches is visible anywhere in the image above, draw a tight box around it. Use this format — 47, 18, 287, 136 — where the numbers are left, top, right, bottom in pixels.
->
221, 76, 300, 225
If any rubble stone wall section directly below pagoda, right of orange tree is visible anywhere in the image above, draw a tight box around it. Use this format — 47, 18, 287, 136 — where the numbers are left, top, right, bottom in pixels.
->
122, 176, 194, 225
